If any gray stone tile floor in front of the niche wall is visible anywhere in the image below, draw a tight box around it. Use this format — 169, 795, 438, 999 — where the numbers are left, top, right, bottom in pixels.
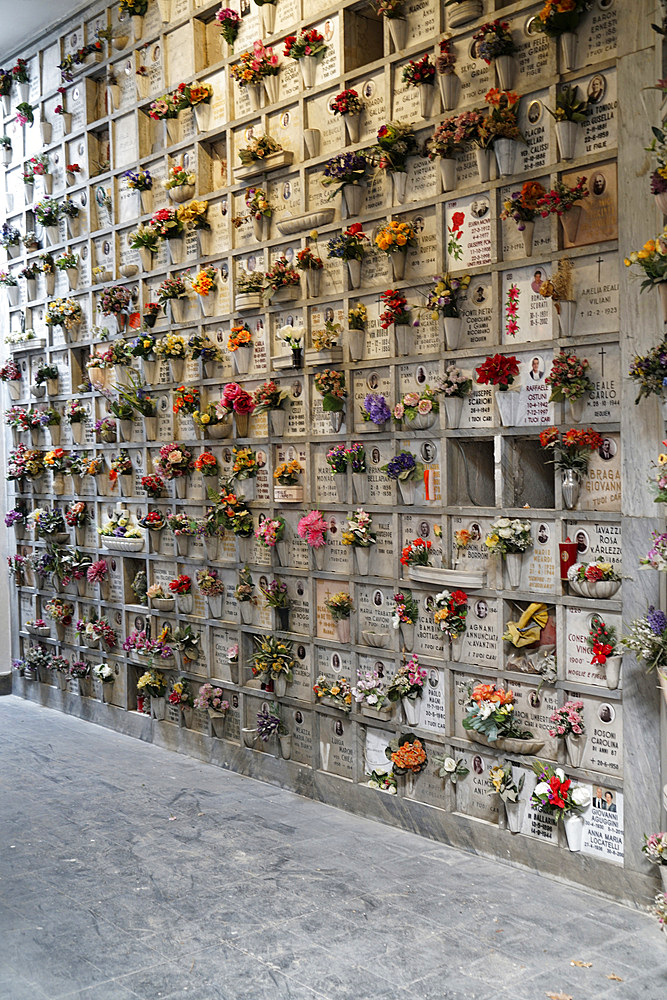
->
0, 697, 667, 1000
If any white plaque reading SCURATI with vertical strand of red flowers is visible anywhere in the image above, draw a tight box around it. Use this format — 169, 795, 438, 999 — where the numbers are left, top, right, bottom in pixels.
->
503, 264, 555, 344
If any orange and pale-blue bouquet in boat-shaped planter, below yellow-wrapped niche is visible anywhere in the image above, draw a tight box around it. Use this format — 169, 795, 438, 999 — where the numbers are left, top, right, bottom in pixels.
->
463, 684, 544, 754
